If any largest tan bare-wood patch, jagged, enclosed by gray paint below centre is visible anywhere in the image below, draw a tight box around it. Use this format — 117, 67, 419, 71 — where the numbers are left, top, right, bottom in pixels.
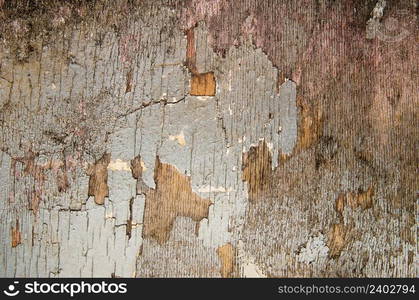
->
143, 157, 212, 244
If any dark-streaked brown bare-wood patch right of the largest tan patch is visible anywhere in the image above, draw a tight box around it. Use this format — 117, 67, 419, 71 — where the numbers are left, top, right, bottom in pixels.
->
242, 141, 272, 201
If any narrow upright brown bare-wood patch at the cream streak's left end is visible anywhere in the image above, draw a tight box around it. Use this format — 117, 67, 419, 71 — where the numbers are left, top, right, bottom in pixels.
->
87, 153, 111, 204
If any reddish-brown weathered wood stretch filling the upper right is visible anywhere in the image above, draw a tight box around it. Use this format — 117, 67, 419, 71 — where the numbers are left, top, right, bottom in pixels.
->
182, 0, 417, 165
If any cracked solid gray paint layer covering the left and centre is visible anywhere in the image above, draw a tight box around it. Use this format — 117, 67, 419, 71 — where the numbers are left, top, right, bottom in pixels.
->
0, 11, 296, 277
